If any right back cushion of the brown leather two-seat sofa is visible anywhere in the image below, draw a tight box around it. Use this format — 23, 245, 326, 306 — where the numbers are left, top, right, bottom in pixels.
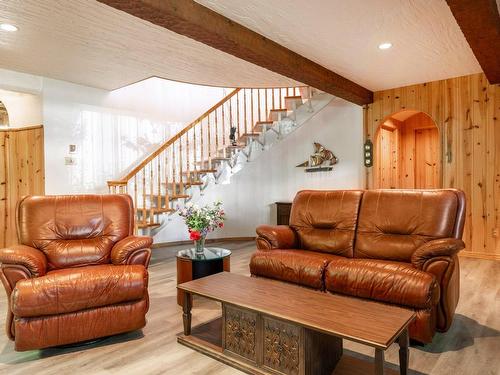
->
354, 189, 465, 262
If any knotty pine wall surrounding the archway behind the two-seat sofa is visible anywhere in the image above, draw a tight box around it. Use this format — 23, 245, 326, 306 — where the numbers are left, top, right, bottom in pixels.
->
364, 74, 500, 259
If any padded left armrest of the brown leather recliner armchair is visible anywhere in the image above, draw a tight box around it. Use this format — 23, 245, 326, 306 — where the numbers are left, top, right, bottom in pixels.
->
0, 245, 47, 277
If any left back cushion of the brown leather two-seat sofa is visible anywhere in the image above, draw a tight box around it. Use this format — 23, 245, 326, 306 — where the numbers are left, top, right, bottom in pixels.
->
290, 190, 363, 257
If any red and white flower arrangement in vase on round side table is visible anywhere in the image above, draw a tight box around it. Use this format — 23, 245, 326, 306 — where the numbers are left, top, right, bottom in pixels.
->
178, 201, 225, 252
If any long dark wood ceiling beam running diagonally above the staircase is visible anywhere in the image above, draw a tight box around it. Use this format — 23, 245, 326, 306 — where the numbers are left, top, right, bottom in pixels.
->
98, 0, 373, 105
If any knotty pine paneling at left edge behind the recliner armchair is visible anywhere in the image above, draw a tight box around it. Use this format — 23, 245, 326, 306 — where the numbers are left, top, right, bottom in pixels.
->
0, 126, 45, 247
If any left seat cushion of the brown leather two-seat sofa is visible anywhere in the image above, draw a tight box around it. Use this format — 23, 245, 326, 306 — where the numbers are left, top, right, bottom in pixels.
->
250, 249, 339, 290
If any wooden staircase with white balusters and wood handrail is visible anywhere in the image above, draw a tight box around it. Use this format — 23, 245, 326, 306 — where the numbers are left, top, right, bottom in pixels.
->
107, 87, 333, 233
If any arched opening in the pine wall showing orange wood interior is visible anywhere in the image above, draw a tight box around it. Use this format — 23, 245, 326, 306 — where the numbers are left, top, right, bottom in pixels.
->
374, 110, 441, 189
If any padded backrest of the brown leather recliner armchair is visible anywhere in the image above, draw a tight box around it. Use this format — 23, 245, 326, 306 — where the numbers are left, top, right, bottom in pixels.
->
17, 194, 134, 269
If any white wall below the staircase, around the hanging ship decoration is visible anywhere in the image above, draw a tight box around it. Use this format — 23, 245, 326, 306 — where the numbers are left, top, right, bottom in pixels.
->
155, 99, 364, 243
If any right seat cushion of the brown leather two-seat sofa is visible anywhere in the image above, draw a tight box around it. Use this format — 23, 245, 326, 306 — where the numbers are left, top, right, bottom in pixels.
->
325, 258, 439, 309
